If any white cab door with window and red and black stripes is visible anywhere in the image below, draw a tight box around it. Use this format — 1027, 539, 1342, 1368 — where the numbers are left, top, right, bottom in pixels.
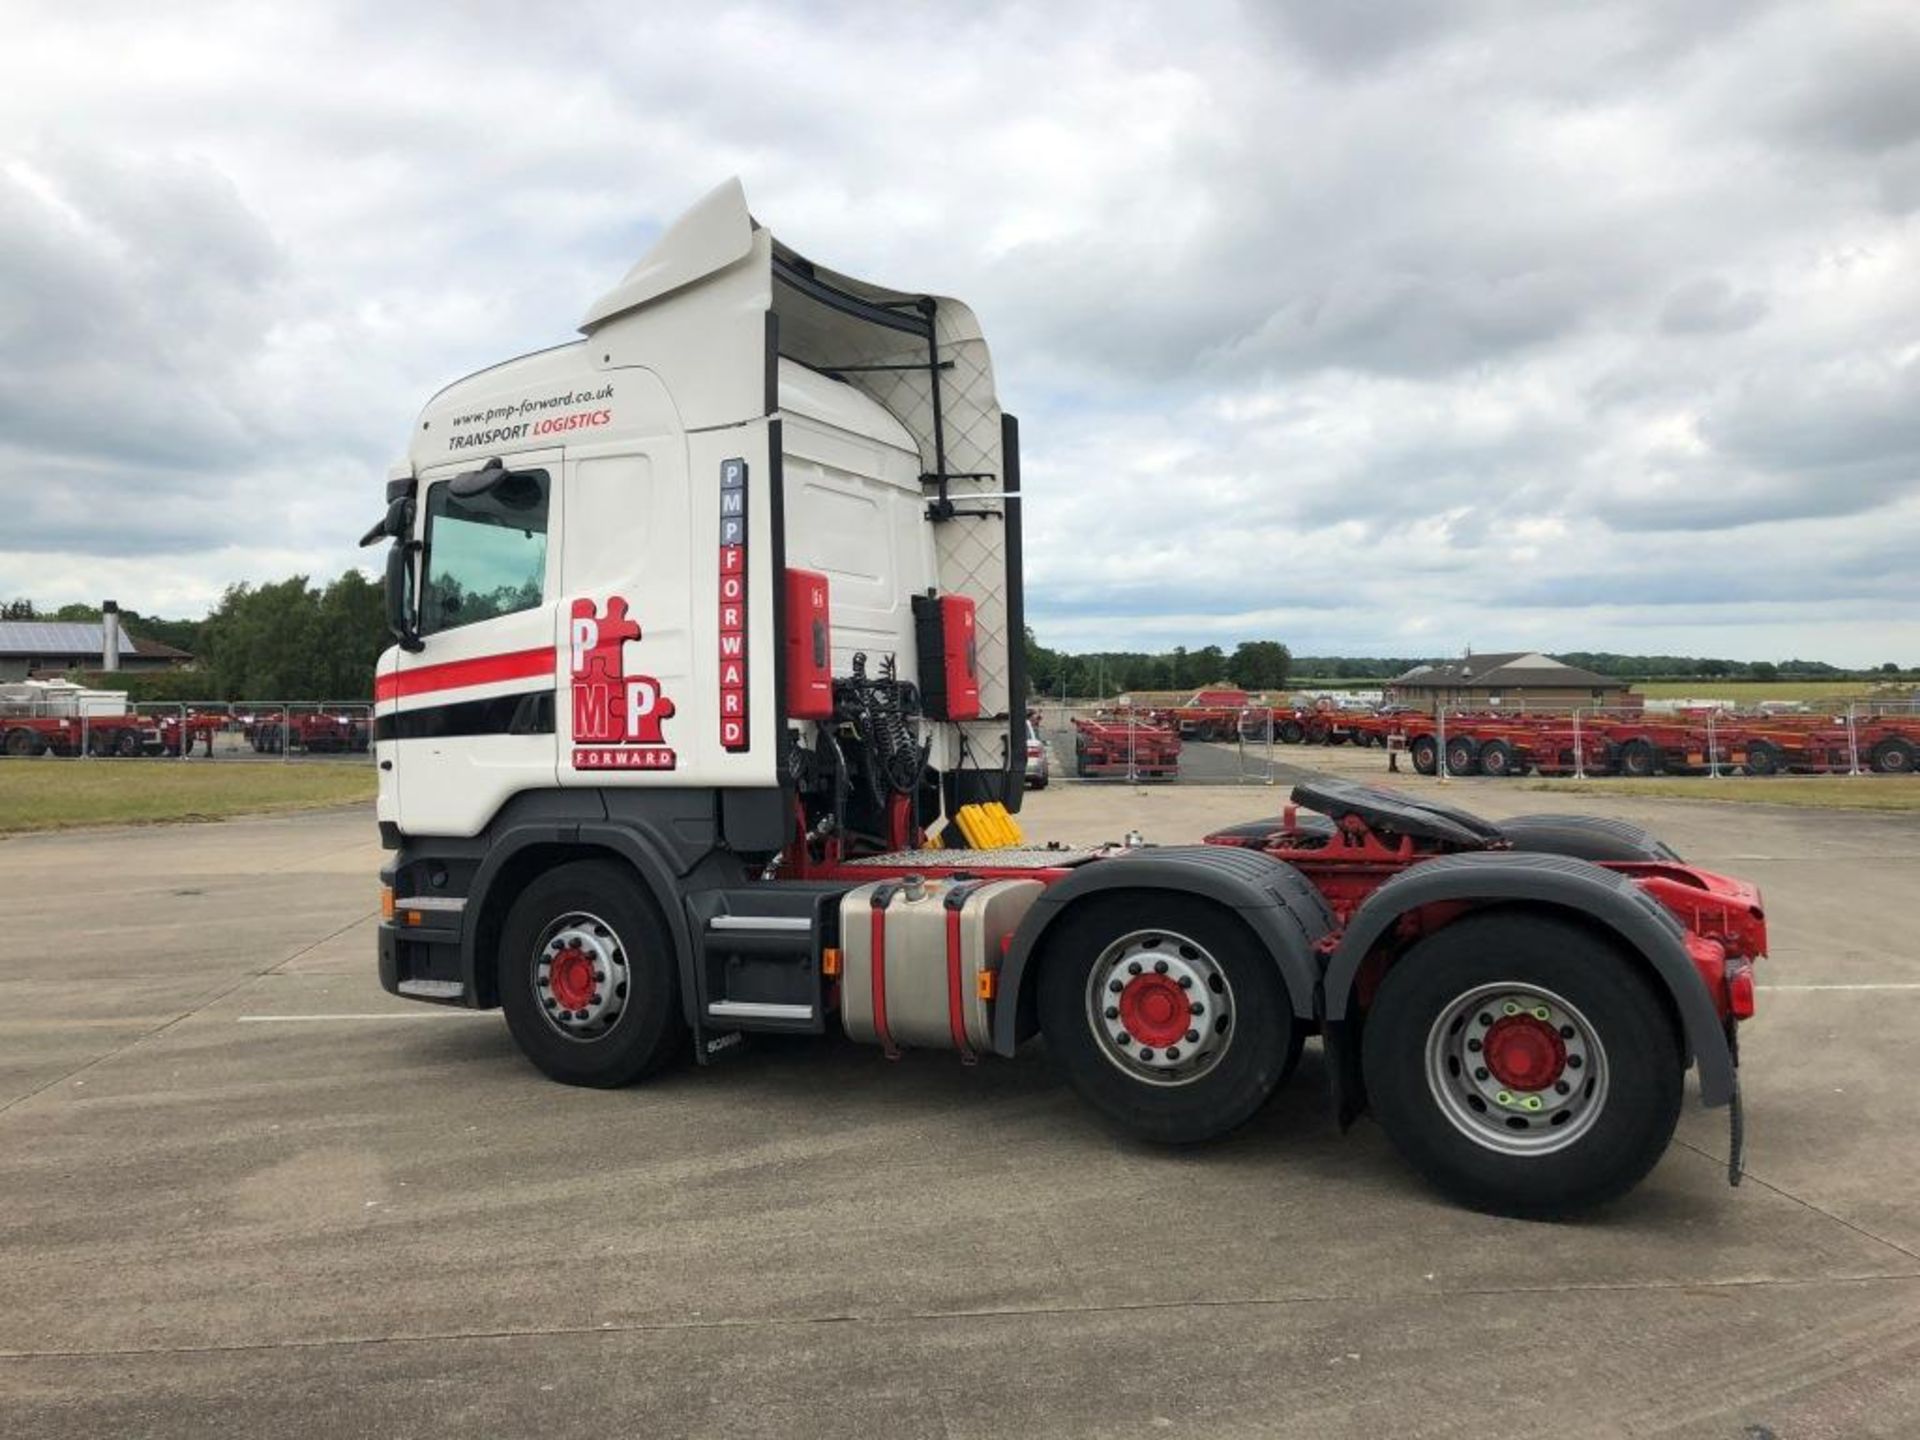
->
382, 449, 564, 835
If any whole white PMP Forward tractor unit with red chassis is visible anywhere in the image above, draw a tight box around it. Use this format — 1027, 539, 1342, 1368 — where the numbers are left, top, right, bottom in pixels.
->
367, 182, 1766, 1215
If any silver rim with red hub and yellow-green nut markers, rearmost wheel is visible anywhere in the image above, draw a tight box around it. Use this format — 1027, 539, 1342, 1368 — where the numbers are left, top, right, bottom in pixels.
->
1427, 981, 1607, 1156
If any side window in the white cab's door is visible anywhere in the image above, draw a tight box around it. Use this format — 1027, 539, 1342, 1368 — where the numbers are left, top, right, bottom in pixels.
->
420, 470, 549, 636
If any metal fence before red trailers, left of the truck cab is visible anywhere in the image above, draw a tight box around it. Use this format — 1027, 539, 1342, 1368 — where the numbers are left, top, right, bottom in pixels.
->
0, 697, 372, 764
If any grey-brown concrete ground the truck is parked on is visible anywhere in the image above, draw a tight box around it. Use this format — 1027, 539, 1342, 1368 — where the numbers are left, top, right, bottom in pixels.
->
0, 781, 1920, 1440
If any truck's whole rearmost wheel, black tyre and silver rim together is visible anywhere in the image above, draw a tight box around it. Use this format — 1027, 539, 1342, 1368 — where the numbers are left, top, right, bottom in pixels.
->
1361, 912, 1686, 1219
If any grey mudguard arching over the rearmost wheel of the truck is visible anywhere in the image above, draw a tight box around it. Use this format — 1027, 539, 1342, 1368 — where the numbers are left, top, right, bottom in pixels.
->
1327, 851, 1734, 1106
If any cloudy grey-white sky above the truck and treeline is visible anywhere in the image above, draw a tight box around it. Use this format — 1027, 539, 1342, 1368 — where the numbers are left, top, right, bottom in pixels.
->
0, 0, 1920, 664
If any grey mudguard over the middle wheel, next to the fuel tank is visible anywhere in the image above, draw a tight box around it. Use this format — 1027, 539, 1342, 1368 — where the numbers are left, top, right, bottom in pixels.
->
993, 845, 1334, 1054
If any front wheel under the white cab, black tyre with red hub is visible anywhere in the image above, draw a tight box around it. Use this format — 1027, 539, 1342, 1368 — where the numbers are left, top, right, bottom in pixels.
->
497, 860, 687, 1089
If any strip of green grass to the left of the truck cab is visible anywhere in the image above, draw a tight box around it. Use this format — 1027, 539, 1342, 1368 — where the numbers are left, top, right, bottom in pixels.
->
0, 756, 374, 835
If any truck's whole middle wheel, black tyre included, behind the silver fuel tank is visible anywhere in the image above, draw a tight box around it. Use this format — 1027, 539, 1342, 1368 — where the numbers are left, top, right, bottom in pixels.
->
1039, 891, 1302, 1144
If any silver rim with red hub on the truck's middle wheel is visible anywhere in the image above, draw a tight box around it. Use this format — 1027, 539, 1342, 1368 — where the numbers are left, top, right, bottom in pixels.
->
1087, 929, 1236, 1085
